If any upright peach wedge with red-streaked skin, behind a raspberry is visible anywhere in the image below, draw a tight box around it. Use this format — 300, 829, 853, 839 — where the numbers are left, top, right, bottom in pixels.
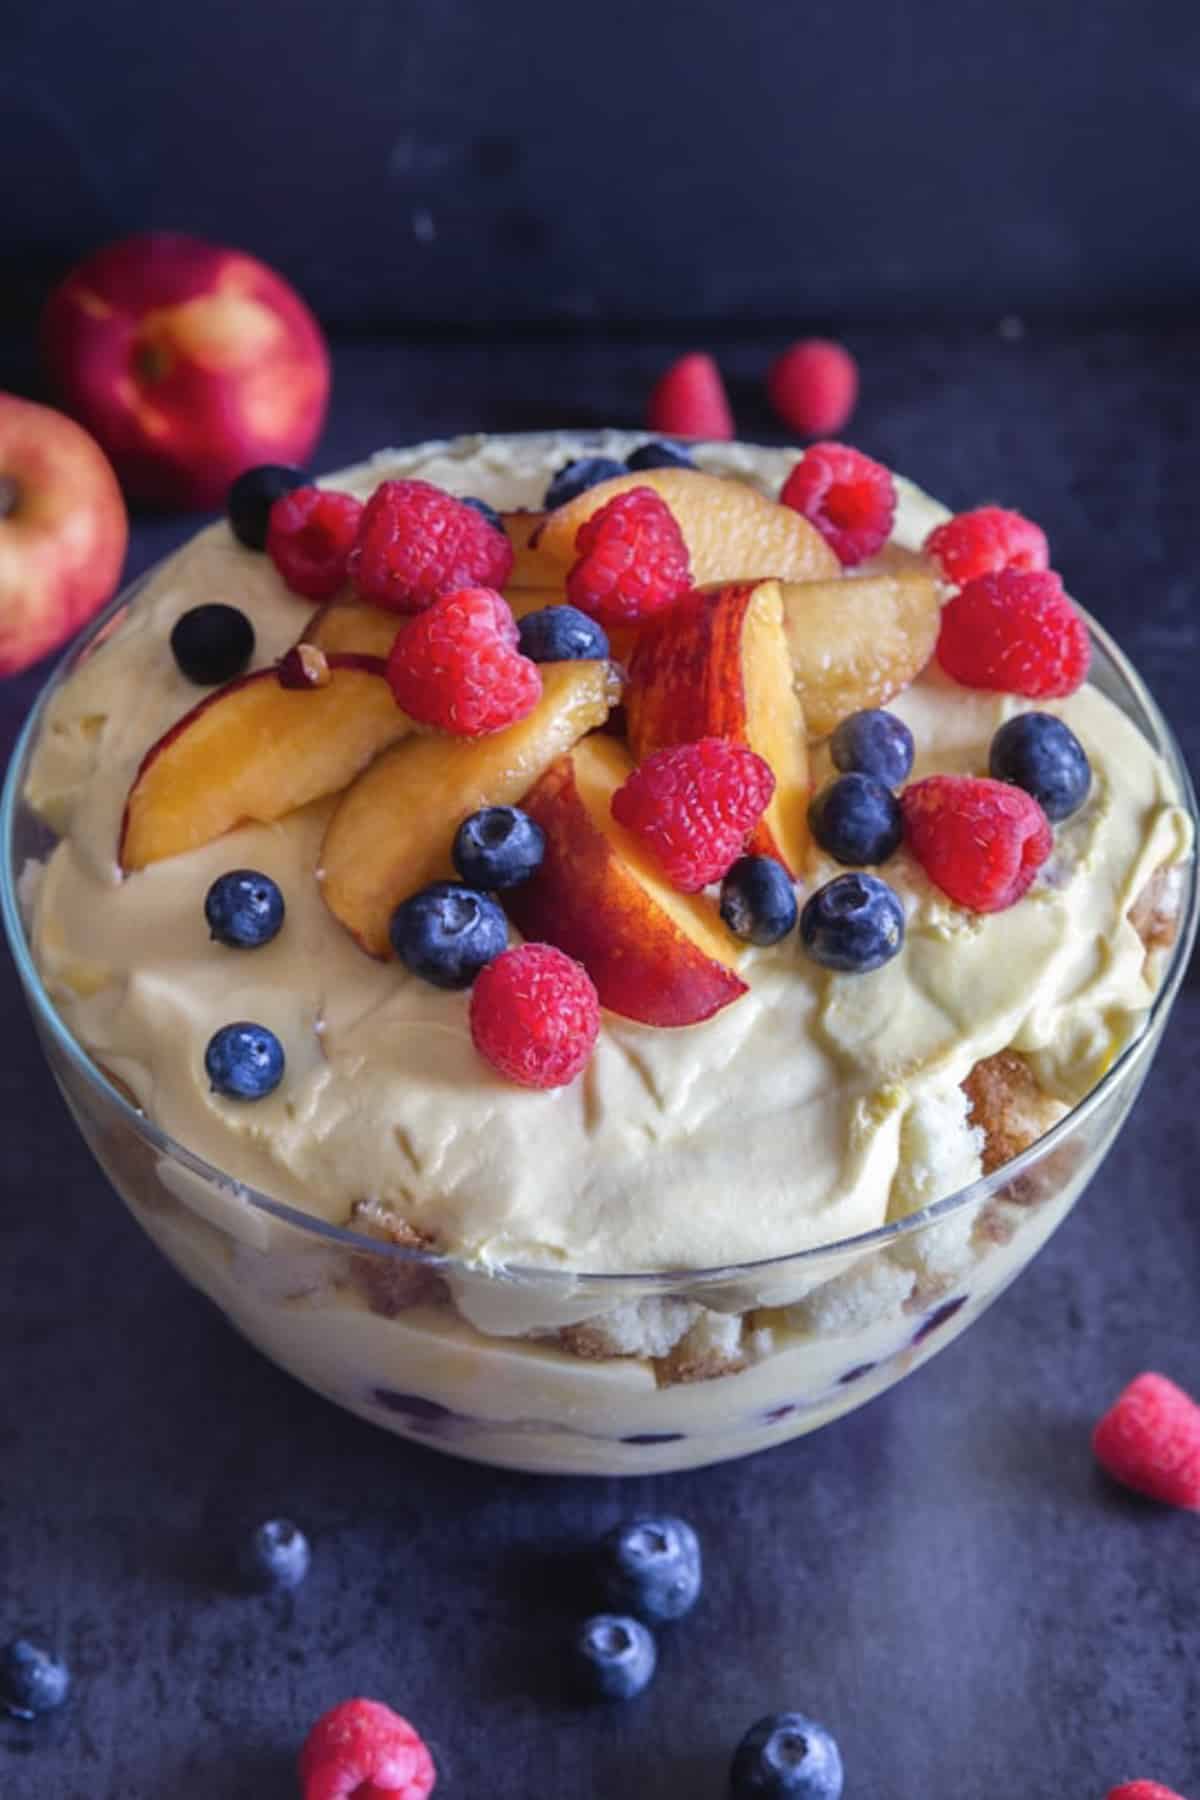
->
624, 581, 810, 878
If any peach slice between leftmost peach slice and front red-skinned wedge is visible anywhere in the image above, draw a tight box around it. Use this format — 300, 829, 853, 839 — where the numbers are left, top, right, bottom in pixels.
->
318, 662, 621, 956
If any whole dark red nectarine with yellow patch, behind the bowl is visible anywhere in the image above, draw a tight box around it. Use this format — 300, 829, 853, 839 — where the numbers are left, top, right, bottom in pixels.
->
41, 232, 329, 508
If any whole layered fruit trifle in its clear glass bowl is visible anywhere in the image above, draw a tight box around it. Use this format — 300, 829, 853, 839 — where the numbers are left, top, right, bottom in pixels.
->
22, 432, 1191, 1472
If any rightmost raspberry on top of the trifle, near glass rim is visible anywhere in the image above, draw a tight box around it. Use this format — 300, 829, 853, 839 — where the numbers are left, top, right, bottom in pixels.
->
937, 569, 1092, 700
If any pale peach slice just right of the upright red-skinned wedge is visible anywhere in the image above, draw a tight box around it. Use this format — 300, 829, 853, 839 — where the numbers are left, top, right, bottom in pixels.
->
783, 571, 941, 738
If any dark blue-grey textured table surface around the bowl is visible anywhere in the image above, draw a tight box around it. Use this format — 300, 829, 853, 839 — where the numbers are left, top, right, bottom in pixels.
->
0, 326, 1200, 1800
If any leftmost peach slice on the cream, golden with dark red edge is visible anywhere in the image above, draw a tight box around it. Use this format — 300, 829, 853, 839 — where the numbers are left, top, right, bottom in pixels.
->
117, 655, 412, 869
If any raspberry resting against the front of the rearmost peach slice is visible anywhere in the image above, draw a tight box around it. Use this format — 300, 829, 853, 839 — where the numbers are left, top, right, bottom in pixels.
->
567, 488, 691, 625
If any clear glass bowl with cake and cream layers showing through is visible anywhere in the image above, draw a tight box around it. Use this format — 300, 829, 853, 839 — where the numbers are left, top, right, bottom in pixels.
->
0, 435, 1196, 1474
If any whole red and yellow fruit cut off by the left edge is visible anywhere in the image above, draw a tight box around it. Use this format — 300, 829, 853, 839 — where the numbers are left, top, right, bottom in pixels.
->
0, 394, 130, 675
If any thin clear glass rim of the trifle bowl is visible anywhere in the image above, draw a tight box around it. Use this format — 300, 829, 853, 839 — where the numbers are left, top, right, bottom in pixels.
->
0, 525, 1200, 1294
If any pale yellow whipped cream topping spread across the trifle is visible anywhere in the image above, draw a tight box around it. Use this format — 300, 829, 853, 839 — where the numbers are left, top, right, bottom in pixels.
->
29, 432, 1189, 1271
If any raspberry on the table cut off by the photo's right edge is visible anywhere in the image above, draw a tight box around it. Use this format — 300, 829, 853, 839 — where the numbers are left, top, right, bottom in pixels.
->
1092, 1375, 1200, 1512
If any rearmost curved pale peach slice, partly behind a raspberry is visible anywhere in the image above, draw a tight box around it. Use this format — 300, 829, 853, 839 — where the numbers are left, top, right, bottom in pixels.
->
533, 468, 840, 587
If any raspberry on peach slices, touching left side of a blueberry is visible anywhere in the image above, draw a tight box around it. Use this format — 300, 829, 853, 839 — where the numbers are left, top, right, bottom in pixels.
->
387, 587, 542, 738
